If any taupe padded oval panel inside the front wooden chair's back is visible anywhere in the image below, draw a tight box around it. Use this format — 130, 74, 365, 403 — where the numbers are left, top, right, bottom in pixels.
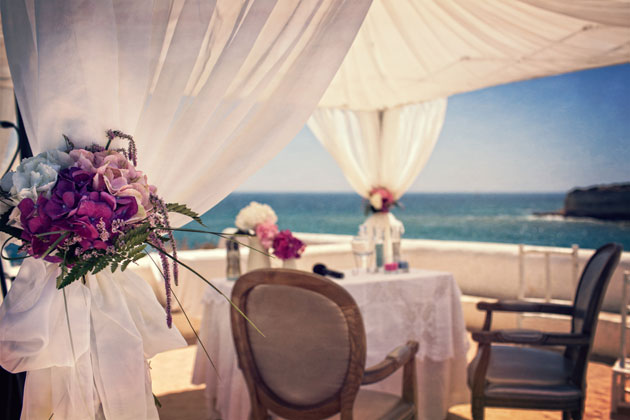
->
247, 285, 350, 406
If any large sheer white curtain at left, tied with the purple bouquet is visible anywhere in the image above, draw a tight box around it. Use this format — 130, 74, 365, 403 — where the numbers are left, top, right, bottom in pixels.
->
0, 0, 371, 420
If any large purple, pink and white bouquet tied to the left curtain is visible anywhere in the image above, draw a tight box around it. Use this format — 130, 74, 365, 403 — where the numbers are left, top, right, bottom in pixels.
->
0, 130, 201, 327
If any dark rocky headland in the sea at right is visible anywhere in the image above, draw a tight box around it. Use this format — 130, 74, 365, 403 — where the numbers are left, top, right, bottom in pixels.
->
562, 183, 630, 220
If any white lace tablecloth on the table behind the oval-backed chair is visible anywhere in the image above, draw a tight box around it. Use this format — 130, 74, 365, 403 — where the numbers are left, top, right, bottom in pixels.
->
193, 270, 469, 420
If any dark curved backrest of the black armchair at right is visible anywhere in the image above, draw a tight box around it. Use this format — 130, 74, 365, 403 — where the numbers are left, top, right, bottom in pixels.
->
565, 243, 622, 382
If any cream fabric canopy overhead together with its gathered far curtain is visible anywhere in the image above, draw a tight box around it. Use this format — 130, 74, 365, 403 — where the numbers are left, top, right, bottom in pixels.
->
309, 0, 630, 213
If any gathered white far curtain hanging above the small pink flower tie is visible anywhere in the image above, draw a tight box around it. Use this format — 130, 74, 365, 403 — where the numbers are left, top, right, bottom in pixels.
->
308, 99, 446, 199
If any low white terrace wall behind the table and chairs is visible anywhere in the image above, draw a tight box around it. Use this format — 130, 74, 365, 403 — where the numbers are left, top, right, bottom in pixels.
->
134, 233, 630, 357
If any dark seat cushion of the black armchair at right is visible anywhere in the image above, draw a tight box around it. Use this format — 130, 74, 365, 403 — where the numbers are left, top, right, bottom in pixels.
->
468, 345, 582, 402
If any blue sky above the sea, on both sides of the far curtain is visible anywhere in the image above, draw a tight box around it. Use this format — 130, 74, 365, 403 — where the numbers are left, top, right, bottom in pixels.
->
237, 64, 630, 192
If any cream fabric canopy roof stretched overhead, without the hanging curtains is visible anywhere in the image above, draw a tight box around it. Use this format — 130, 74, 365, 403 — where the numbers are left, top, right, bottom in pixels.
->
319, 0, 630, 110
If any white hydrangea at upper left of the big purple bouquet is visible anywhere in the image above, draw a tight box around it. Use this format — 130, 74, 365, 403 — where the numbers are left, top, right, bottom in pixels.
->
0, 150, 74, 214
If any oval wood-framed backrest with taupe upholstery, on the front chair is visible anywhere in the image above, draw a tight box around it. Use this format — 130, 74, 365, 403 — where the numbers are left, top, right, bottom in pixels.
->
231, 269, 366, 419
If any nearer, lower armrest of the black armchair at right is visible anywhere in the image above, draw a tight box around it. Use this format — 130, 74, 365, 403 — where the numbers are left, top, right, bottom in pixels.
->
472, 330, 590, 346
